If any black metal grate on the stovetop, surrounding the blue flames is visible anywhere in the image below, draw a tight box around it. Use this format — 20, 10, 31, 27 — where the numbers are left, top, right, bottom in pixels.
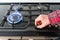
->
0, 4, 52, 29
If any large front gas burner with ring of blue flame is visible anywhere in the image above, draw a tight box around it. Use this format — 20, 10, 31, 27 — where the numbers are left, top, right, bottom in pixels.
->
7, 11, 23, 24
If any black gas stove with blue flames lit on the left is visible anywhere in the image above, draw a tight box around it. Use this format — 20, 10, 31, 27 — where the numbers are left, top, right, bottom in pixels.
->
0, 3, 59, 36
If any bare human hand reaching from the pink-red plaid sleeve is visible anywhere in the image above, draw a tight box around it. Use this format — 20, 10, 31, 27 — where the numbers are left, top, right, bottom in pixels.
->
35, 14, 50, 29
